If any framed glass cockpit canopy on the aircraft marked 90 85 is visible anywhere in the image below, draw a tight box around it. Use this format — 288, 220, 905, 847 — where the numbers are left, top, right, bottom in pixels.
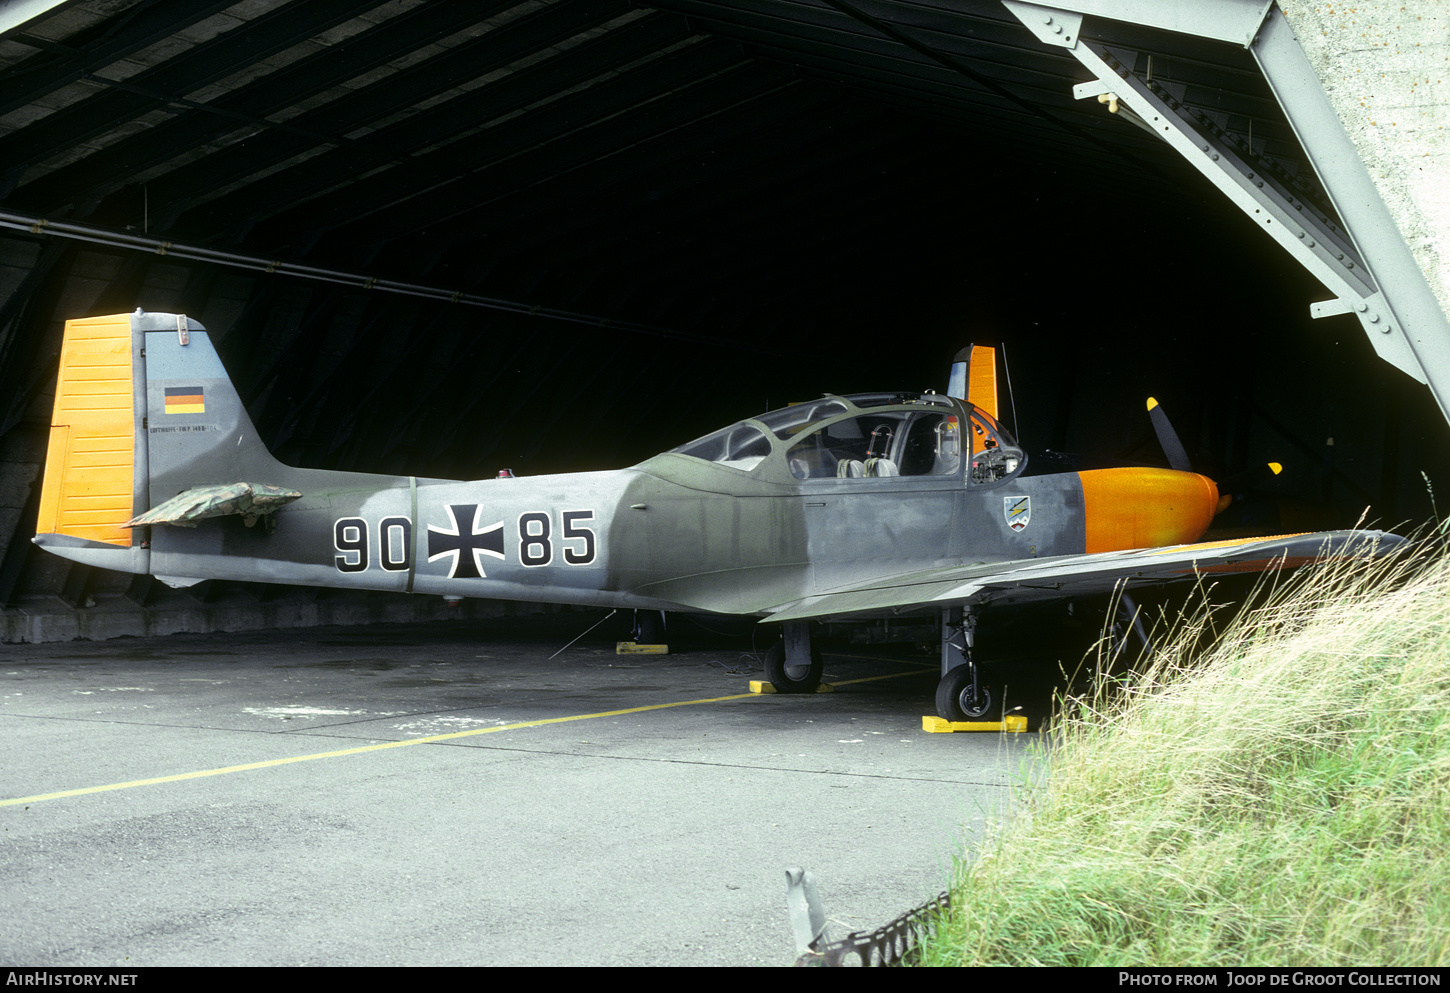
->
671, 393, 1027, 486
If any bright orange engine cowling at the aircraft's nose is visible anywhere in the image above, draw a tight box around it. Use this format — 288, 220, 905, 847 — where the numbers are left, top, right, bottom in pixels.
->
1077, 468, 1218, 552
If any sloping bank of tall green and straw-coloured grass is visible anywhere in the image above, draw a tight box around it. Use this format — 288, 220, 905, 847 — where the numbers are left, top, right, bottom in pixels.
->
922, 542, 1450, 965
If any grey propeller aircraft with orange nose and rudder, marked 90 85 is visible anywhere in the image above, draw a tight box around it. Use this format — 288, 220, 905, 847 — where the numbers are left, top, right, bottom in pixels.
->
35, 310, 1402, 720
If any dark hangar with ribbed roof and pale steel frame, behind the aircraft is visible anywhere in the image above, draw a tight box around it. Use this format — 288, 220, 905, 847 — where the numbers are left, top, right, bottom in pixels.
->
0, 0, 1450, 641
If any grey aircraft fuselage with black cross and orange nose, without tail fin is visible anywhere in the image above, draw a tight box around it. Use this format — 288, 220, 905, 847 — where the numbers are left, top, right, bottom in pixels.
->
136, 454, 1217, 613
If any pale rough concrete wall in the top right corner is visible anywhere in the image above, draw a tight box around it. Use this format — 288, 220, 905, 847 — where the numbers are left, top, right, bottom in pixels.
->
1280, 0, 1450, 313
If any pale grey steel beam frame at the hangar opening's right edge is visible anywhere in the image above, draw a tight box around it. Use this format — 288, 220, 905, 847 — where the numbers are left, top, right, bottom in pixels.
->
1002, 0, 1450, 422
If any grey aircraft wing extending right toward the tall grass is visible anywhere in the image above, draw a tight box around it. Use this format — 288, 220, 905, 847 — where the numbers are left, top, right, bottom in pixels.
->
764, 531, 1405, 620
